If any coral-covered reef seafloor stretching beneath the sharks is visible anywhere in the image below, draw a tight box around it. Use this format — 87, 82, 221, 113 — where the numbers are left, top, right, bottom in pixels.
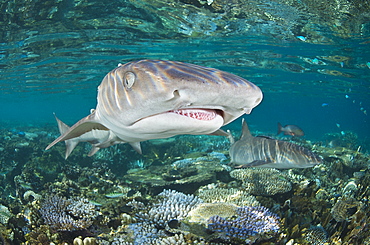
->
0, 123, 370, 244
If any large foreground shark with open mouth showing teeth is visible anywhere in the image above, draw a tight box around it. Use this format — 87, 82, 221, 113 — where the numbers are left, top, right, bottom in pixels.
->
46, 59, 263, 157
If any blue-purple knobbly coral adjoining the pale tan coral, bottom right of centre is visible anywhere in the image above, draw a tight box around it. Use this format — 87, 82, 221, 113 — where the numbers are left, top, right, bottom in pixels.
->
208, 206, 280, 240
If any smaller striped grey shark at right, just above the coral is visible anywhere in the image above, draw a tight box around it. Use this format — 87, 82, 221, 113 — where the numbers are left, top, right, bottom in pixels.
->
229, 120, 322, 169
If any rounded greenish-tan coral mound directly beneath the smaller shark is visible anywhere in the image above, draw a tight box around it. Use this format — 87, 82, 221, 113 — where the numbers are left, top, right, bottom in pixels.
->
230, 168, 292, 196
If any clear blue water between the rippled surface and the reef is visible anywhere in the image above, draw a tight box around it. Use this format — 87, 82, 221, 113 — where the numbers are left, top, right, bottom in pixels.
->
0, 33, 370, 149
